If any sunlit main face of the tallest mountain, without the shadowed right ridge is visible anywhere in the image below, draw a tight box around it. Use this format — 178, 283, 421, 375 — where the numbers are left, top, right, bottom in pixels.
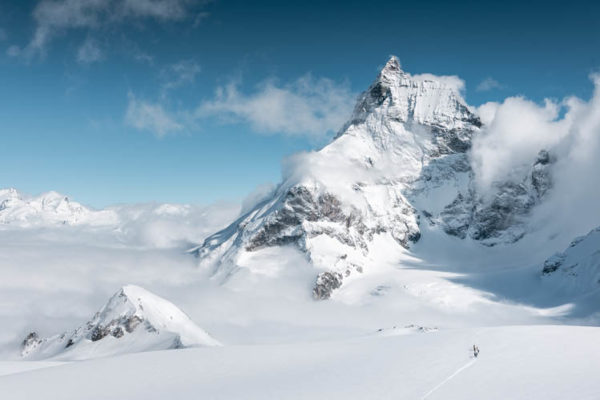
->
192, 57, 481, 299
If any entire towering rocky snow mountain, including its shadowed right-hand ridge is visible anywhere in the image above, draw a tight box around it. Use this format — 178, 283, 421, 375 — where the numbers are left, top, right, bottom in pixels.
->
191, 57, 553, 299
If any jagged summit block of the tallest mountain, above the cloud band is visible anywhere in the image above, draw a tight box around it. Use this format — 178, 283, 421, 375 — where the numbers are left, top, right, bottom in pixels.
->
338, 57, 481, 157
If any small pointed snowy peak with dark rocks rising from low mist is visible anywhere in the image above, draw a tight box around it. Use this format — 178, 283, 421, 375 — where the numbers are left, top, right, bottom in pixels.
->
21, 285, 224, 359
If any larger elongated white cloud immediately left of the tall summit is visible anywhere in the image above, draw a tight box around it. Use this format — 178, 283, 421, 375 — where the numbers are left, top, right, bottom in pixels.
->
196, 75, 355, 137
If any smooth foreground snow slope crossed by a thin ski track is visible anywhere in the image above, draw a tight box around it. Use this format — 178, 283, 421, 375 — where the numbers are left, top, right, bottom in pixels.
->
0, 326, 600, 400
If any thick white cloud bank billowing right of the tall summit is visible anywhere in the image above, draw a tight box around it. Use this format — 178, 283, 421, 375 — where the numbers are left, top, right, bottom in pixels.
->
472, 74, 600, 239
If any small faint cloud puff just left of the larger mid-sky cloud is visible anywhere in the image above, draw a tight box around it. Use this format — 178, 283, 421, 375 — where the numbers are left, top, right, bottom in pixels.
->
125, 93, 183, 137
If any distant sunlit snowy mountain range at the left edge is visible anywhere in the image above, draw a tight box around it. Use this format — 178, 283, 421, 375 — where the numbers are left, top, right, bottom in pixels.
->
0, 188, 118, 227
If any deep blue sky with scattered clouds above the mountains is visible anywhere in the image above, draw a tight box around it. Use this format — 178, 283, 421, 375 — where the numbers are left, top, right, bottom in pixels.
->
0, 0, 600, 207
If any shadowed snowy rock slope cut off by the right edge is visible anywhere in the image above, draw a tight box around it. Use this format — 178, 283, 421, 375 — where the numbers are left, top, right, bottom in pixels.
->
542, 227, 600, 294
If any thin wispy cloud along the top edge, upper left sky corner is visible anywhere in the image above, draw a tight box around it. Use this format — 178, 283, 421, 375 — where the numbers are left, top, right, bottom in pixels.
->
9, 0, 198, 57
